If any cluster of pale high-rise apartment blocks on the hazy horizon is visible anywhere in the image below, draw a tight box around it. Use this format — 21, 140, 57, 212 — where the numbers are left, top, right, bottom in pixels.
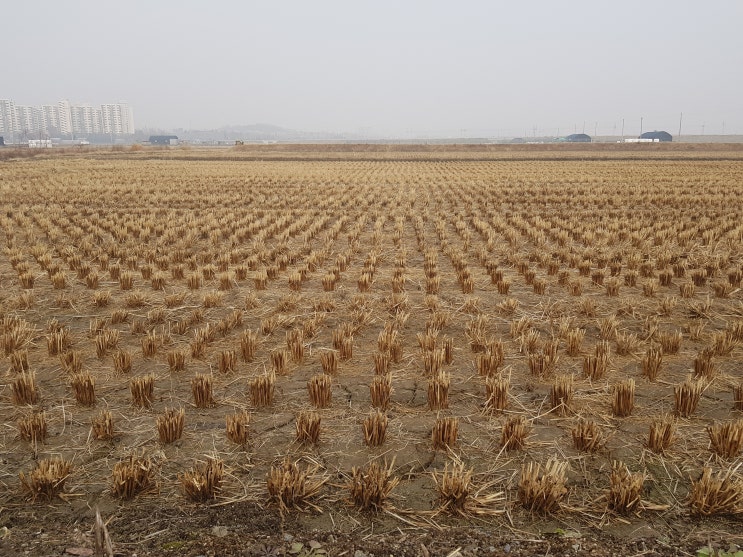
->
0, 99, 134, 141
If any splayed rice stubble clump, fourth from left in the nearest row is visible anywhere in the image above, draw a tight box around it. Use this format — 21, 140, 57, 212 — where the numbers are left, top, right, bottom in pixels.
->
266, 457, 328, 515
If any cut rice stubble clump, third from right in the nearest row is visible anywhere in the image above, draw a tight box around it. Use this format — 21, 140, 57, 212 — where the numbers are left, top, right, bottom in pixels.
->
518, 459, 568, 514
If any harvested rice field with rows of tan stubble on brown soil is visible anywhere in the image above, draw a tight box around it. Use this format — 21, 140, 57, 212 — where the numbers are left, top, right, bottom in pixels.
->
0, 146, 743, 555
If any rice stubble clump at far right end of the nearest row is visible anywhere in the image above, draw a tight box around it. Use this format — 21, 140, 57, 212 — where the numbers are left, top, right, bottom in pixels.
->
689, 464, 743, 516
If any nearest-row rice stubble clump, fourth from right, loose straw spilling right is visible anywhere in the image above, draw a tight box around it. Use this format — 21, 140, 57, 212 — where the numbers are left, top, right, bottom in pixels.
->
431, 462, 504, 517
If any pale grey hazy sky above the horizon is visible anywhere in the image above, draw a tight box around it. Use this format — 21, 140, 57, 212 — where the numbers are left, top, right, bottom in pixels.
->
0, 0, 743, 136
